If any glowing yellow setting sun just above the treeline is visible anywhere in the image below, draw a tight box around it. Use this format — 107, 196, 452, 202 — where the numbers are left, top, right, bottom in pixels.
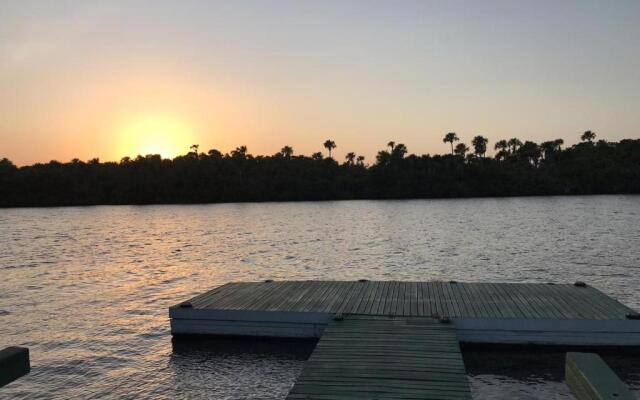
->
118, 115, 194, 158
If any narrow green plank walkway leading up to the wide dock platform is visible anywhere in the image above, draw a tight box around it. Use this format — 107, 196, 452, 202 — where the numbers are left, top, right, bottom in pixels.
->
287, 315, 471, 400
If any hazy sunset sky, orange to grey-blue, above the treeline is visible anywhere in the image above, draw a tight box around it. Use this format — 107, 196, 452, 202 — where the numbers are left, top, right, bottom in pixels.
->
0, 0, 640, 165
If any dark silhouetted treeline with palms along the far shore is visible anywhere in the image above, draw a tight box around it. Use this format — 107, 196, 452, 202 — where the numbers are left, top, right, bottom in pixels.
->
0, 131, 640, 207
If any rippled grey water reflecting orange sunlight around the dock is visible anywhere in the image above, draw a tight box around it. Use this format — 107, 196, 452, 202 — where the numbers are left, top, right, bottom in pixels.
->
0, 196, 640, 399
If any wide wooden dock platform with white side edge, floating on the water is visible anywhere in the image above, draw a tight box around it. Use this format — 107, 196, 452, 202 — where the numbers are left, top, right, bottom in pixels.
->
169, 281, 640, 346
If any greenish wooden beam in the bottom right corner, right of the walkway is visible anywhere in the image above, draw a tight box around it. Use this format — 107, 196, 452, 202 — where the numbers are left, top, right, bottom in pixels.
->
565, 353, 635, 400
